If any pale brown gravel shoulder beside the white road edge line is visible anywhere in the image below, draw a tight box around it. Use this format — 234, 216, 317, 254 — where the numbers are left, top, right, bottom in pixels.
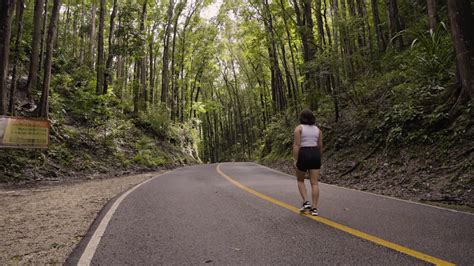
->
0, 172, 159, 265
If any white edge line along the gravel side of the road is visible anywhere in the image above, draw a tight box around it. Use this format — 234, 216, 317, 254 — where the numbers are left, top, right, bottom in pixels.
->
77, 171, 170, 266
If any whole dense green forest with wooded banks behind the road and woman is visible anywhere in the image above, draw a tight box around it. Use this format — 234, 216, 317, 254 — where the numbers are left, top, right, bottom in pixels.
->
0, 0, 474, 206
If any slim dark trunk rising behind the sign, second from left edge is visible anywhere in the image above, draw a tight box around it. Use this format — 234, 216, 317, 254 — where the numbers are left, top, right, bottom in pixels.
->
8, 0, 25, 116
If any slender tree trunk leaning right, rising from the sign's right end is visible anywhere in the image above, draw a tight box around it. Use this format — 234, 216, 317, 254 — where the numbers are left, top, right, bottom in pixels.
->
39, 0, 61, 118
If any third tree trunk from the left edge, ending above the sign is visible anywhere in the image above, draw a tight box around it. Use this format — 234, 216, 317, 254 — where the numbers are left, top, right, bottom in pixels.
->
26, 0, 44, 100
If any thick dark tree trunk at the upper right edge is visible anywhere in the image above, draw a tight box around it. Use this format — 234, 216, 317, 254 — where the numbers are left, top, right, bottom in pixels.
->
448, 0, 474, 103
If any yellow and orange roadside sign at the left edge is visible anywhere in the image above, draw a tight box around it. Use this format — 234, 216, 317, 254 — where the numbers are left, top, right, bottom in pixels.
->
0, 116, 49, 149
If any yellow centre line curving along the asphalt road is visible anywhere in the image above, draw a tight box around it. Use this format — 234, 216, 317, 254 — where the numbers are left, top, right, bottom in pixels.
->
216, 164, 455, 265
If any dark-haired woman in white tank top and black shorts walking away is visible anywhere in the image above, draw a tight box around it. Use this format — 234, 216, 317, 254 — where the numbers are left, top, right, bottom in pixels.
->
293, 110, 323, 216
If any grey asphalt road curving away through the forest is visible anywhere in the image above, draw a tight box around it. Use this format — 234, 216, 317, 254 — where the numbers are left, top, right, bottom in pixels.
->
66, 163, 474, 265
